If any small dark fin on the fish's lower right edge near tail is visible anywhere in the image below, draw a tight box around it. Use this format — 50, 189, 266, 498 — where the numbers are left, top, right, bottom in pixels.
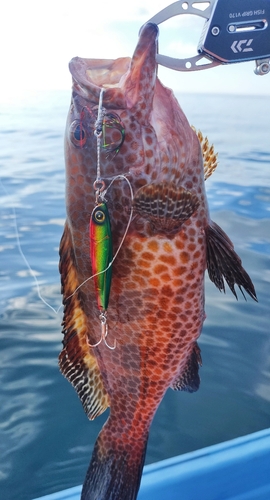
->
171, 342, 202, 392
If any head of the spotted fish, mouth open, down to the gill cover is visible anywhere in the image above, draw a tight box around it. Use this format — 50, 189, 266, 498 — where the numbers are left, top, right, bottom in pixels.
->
65, 23, 198, 200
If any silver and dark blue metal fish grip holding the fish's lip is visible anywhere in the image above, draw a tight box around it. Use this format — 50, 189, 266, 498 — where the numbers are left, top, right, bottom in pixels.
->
148, 0, 270, 75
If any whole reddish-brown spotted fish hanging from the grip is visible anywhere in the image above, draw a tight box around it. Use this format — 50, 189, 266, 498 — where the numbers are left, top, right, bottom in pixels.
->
59, 23, 257, 500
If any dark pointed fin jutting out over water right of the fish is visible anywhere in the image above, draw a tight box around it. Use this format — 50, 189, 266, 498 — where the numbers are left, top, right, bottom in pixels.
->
205, 222, 257, 301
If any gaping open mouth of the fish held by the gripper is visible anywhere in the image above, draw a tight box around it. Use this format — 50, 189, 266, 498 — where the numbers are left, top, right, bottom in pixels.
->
69, 23, 159, 108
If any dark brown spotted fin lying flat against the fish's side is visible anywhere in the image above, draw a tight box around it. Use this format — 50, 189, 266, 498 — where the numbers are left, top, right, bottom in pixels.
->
133, 182, 199, 233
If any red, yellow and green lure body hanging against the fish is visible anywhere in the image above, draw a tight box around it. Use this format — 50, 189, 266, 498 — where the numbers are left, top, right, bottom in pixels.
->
89, 203, 113, 311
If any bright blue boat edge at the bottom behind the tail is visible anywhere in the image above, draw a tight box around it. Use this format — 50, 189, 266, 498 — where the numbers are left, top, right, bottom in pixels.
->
35, 429, 270, 500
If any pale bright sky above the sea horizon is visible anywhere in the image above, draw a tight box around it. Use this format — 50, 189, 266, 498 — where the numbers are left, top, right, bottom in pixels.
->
0, 0, 270, 98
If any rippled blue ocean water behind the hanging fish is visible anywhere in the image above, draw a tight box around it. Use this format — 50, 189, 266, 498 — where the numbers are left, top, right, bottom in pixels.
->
0, 92, 270, 500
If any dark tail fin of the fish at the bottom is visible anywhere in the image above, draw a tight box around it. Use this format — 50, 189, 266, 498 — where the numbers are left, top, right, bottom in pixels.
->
81, 425, 148, 500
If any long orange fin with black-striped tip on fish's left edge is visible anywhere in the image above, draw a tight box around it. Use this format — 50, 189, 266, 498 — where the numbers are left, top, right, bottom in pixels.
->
59, 223, 110, 420
